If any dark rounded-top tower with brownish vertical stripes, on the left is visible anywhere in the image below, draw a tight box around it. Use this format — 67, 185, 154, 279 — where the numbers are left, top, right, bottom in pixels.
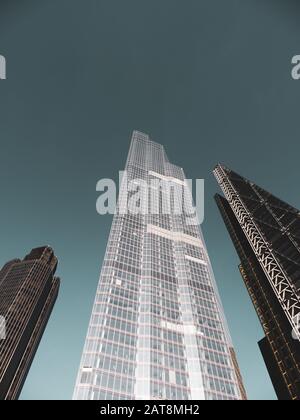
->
0, 247, 59, 400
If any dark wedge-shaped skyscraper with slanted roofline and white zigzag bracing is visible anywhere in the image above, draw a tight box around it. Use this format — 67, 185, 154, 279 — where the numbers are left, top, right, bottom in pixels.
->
214, 165, 300, 400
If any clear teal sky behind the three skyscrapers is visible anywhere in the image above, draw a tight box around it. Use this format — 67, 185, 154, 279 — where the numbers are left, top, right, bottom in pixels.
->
0, 0, 300, 399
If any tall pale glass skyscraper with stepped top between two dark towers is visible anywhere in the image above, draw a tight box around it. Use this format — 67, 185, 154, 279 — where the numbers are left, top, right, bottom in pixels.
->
73, 132, 246, 400
